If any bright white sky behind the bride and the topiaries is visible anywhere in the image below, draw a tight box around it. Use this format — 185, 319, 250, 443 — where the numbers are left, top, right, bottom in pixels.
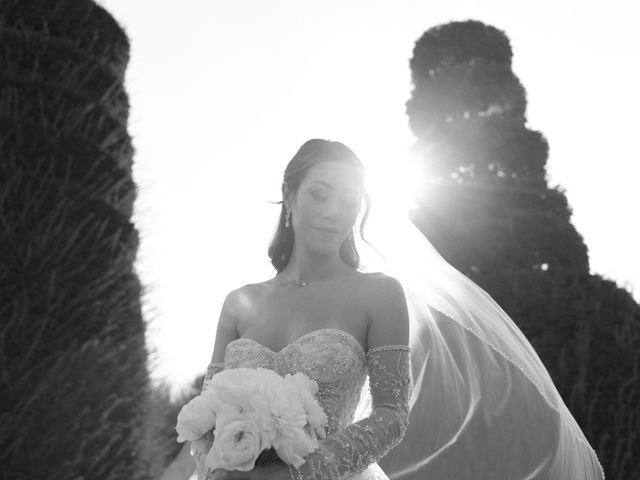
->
98, 0, 640, 393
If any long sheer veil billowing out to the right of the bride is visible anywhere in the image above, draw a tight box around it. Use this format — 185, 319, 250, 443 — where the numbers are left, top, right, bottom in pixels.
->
356, 197, 604, 480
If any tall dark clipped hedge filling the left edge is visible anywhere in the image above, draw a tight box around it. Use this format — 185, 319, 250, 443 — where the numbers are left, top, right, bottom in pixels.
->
0, 0, 157, 479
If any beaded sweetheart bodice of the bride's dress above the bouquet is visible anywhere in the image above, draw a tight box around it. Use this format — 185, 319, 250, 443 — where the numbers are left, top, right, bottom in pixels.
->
225, 328, 367, 434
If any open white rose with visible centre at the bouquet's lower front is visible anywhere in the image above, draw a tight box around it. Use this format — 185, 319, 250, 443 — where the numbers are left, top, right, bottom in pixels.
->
205, 408, 264, 472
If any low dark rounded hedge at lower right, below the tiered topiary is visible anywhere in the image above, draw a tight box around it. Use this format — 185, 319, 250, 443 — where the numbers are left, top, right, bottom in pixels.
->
497, 271, 640, 479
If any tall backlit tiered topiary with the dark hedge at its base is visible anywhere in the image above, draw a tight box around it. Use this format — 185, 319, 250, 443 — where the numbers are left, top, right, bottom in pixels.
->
407, 21, 640, 480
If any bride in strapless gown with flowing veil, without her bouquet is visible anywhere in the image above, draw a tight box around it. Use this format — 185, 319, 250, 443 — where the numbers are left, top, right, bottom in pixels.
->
188, 140, 603, 480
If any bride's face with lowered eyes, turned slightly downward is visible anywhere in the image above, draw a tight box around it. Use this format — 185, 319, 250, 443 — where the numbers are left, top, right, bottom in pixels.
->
290, 161, 362, 254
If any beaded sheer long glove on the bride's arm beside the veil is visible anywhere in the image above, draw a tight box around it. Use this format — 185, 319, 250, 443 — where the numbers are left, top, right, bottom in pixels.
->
289, 345, 411, 480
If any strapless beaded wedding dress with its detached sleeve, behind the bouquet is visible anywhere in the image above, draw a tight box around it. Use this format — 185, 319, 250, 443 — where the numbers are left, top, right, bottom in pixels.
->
200, 328, 411, 480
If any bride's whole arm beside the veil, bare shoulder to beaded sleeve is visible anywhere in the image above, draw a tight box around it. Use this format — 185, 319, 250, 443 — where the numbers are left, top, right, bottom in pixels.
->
291, 276, 411, 480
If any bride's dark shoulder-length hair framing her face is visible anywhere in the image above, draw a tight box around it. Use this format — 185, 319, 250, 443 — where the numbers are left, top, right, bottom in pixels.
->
269, 139, 371, 273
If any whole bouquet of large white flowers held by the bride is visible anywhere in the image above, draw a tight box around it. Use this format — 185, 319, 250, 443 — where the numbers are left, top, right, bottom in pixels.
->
176, 368, 327, 471
